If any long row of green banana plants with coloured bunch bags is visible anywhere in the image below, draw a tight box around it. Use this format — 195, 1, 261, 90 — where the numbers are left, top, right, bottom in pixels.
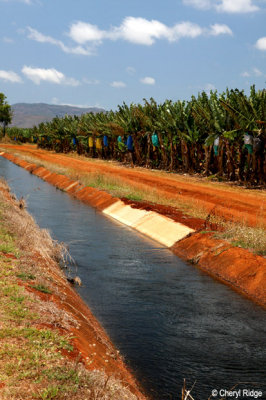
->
4, 86, 266, 186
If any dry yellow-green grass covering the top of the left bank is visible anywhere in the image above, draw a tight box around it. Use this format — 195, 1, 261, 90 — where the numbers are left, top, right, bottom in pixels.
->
0, 181, 140, 400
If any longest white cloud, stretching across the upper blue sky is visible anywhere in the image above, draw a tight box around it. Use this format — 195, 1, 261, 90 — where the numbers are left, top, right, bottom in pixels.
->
23, 17, 233, 57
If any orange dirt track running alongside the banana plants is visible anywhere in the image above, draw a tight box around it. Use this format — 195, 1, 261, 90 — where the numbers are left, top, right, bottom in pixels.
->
1, 144, 266, 226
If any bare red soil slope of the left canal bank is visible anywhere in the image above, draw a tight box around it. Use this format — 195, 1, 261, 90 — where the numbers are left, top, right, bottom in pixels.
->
18, 274, 145, 400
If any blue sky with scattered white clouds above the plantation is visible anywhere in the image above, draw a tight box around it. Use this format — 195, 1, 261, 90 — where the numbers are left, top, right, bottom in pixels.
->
0, 0, 266, 110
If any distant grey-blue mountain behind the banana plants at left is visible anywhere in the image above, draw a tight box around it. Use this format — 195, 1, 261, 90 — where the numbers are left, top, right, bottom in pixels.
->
9, 103, 104, 128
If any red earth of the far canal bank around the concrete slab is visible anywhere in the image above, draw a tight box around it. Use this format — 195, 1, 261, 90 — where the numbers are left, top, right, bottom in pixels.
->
2, 149, 266, 306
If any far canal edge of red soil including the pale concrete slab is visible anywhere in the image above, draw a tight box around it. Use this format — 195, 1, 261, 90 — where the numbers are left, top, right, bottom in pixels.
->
0, 152, 266, 308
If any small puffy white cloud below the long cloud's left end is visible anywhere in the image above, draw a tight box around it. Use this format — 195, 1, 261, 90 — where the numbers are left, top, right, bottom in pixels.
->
22, 65, 79, 86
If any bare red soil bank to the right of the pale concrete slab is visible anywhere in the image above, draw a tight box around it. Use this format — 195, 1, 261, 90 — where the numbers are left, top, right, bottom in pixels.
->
172, 233, 266, 307
